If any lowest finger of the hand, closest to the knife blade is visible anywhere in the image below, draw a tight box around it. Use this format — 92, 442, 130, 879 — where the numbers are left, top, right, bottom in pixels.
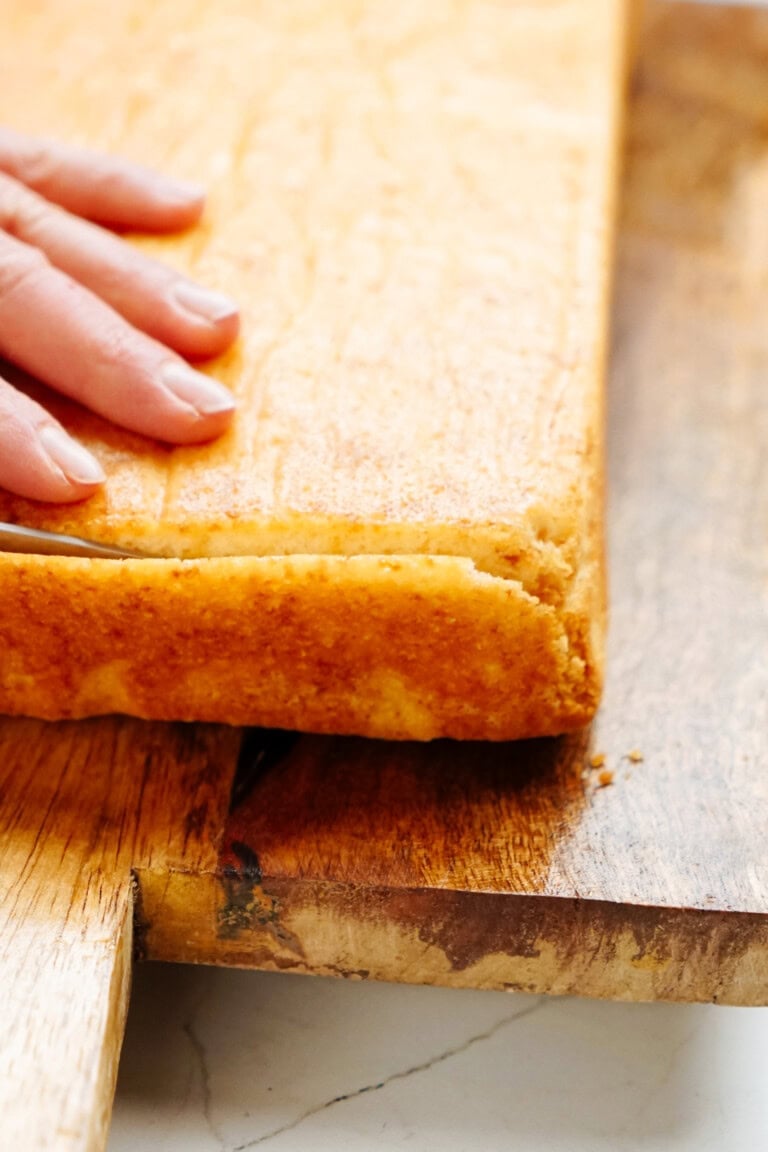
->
0, 378, 105, 503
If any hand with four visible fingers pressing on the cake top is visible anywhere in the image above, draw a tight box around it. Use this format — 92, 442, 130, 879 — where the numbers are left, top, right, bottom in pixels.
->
0, 129, 238, 503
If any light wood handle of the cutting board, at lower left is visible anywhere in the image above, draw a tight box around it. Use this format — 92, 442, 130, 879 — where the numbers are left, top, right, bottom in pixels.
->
0, 720, 239, 1152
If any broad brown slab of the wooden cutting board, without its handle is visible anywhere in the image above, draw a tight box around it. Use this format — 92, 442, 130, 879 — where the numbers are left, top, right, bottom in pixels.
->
133, 6, 768, 1003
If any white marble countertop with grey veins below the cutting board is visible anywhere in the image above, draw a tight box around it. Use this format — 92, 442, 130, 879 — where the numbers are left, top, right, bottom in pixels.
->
109, 965, 768, 1152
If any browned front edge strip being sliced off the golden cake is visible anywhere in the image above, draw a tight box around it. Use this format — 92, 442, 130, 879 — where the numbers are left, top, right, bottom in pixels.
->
0, 556, 602, 740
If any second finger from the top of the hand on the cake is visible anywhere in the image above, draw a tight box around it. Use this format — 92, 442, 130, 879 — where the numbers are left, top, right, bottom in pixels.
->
0, 174, 238, 358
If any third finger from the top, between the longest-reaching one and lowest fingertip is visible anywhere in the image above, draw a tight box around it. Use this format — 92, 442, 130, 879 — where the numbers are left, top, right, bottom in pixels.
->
0, 233, 235, 444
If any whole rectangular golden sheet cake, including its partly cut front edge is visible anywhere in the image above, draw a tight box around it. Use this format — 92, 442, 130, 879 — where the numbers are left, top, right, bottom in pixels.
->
0, 0, 626, 740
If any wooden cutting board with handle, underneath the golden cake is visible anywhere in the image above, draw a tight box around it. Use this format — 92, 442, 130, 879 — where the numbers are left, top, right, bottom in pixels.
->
0, 5, 768, 1152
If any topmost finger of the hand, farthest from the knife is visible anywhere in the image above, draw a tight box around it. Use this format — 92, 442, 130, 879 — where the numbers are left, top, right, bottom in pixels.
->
0, 128, 205, 232
